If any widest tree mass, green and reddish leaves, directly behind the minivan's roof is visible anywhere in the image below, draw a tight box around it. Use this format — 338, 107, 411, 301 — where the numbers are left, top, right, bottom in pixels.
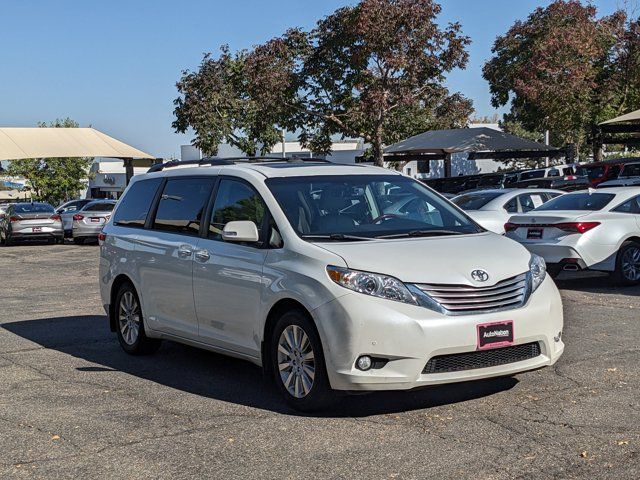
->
174, 0, 472, 165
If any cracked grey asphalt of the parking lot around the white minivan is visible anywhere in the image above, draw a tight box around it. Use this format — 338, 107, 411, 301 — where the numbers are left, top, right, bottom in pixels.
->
0, 244, 640, 479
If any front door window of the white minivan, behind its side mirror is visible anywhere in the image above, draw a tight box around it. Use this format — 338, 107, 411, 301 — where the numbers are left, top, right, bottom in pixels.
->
209, 179, 267, 241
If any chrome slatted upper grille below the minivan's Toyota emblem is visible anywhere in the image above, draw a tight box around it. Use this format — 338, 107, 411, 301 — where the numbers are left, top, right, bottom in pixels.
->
416, 273, 528, 315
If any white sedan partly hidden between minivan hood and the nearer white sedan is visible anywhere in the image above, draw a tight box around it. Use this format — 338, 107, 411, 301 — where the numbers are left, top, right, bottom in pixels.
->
451, 188, 564, 233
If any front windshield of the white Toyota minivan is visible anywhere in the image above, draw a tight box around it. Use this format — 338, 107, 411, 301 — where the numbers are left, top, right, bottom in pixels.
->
266, 175, 483, 240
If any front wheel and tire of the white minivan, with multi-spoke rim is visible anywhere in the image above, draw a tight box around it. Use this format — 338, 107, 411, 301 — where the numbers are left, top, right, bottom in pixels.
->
269, 310, 333, 412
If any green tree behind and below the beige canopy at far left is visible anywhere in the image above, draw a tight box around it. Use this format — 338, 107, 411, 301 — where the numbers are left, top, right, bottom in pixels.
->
4, 118, 92, 205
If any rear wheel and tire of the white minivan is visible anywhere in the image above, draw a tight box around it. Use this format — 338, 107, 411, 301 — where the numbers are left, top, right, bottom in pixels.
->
113, 283, 161, 355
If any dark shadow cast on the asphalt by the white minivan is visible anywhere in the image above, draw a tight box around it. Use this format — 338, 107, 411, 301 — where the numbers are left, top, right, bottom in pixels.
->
0, 315, 518, 417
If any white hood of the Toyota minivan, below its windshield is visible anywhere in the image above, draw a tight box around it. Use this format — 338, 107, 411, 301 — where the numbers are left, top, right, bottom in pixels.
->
316, 232, 531, 286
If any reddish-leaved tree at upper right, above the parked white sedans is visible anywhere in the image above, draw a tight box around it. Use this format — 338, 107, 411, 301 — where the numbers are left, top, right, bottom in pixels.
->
483, 0, 625, 156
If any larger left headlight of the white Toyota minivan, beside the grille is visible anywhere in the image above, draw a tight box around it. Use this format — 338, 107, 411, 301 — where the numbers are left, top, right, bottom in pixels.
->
327, 266, 418, 305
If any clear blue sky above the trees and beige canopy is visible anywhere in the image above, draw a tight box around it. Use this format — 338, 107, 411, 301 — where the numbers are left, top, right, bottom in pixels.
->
0, 0, 622, 158
